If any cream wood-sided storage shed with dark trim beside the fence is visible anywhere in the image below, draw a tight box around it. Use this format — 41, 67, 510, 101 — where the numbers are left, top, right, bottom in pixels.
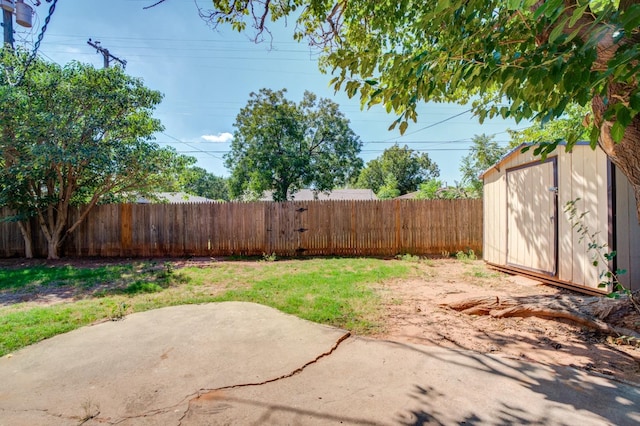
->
481, 143, 640, 293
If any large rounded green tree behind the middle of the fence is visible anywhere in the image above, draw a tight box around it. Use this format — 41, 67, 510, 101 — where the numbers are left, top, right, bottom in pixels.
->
226, 89, 362, 201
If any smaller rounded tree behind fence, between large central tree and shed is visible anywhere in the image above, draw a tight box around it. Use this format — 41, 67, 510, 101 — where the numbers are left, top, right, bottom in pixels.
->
356, 144, 440, 195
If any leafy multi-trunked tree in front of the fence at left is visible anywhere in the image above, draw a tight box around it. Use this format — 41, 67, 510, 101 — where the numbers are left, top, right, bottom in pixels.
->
0, 50, 187, 259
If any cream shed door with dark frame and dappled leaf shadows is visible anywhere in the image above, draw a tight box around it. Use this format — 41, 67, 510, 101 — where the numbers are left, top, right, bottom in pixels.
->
507, 158, 558, 276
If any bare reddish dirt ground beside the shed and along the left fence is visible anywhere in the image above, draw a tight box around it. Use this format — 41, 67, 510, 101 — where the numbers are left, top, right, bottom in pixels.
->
0, 259, 640, 385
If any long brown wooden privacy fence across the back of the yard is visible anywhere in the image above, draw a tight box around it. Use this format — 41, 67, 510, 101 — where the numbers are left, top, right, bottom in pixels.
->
0, 200, 482, 257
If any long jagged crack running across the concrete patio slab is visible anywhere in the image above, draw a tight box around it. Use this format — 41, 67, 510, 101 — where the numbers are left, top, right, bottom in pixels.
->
93, 332, 351, 426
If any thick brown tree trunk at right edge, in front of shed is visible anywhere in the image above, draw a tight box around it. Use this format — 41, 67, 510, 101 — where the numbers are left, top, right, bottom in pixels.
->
592, 88, 640, 223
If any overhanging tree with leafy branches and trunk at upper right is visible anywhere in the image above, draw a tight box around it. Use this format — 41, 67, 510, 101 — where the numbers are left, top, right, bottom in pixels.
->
202, 0, 640, 218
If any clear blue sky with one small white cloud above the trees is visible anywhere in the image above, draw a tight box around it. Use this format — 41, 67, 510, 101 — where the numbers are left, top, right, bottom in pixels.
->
16, 0, 526, 184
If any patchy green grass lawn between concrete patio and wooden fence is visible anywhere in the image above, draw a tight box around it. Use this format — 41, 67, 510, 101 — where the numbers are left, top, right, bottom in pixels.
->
0, 258, 416, 356
